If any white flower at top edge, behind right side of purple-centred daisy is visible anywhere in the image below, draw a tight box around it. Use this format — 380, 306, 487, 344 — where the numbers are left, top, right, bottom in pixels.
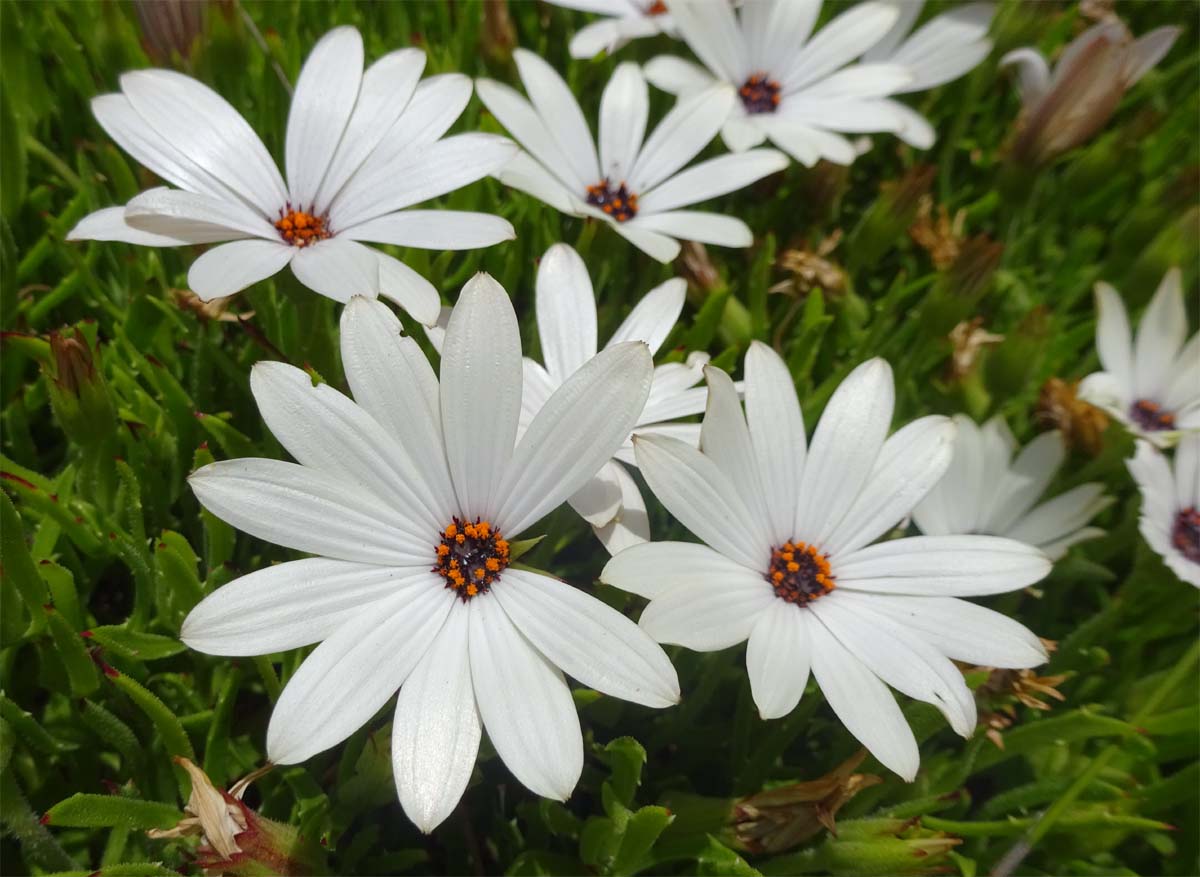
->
862, 0, 996, 149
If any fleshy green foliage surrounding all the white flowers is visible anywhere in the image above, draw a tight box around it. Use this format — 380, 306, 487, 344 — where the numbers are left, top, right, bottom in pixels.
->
0, 0, 1200, 875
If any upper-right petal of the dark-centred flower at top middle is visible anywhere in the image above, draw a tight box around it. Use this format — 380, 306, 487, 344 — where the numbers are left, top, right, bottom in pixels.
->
630, 85, 734, 193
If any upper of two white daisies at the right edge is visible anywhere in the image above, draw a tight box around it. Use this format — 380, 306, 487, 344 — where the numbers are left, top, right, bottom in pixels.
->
1079, 268, 1200, 447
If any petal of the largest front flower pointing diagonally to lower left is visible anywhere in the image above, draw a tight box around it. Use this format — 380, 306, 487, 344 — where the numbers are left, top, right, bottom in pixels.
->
266, 583, 456, 764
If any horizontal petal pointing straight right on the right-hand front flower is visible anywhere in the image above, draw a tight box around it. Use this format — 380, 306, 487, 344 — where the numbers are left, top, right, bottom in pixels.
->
832, 535, 1050, 596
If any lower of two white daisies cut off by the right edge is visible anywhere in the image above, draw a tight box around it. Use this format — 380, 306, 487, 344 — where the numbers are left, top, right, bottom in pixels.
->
1127, 433, 1200, 588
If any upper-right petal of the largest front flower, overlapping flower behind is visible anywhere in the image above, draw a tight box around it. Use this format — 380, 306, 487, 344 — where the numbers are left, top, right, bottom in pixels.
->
497, 342, 654, 537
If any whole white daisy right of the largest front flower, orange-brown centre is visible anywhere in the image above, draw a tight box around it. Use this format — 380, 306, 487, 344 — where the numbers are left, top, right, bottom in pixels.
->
600, 342, 1050, 780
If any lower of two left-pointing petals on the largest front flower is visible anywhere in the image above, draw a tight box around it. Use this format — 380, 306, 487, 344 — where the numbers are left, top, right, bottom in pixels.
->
179, 558, 430, 656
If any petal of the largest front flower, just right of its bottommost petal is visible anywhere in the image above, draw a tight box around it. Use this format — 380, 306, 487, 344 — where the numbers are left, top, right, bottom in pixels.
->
468, 597, 583, 801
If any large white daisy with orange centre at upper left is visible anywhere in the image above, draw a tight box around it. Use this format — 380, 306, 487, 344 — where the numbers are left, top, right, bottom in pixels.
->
67, 28, 516, 323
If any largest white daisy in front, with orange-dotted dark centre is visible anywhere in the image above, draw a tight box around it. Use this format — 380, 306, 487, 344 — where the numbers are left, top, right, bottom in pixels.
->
181, 275, 679, 831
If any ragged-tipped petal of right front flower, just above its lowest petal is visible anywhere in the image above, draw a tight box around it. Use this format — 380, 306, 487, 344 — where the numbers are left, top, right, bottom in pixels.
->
809, 591, 976, 737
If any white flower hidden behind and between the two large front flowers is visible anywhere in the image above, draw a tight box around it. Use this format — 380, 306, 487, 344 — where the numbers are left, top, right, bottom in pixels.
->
520, 244, 708, 554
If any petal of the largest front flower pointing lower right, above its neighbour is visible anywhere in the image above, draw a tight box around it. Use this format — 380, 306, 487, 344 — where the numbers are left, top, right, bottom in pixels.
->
492, 569, 679, 708
